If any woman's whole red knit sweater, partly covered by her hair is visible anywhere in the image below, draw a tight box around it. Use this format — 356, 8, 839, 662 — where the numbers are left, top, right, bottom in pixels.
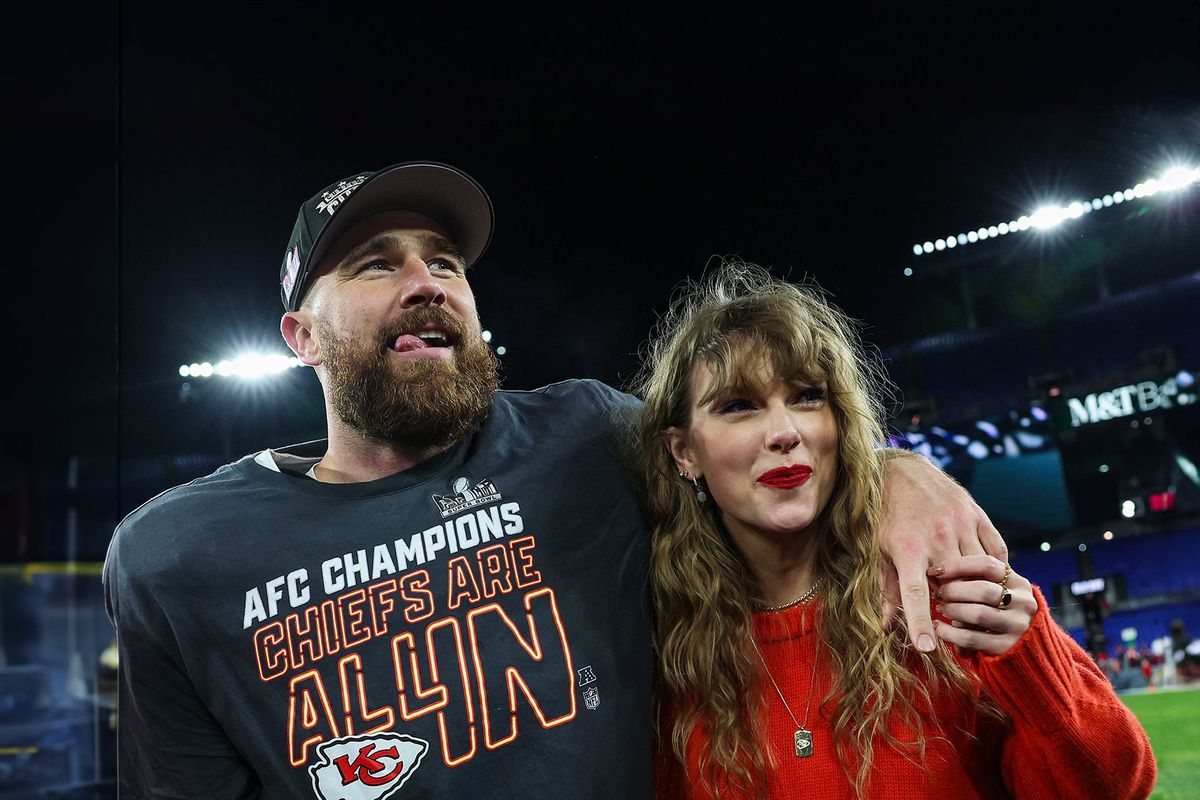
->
658, 589, 1156, 800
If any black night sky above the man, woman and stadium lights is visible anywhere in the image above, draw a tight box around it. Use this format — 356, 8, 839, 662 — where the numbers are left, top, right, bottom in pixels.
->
2, 2, 1200, 482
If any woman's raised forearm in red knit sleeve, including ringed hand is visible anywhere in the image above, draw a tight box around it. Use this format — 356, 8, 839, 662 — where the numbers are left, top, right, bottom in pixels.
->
936, 557, 1157, 800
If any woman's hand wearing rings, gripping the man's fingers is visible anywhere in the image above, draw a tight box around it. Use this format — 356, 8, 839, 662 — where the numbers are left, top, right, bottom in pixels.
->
929, 555, 1038, 656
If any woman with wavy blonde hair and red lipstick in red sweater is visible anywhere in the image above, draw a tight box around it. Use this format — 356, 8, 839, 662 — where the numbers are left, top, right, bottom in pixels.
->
638, 264, 1156, 800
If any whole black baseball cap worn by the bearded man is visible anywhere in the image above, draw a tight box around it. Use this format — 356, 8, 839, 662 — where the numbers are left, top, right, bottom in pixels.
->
280, 161, 496, 311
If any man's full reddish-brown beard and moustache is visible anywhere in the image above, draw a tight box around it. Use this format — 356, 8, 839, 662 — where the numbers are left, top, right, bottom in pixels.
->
317, 307, 500, 450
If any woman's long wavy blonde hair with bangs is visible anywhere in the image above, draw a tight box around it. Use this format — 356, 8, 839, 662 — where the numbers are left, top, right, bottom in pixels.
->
634, 261, 976, 796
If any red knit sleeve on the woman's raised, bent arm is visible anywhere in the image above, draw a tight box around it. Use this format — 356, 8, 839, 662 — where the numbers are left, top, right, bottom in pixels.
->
977, 588, 1157, 800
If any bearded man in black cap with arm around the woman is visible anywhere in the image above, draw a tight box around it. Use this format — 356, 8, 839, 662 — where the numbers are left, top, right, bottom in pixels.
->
104, 162, 1004, 800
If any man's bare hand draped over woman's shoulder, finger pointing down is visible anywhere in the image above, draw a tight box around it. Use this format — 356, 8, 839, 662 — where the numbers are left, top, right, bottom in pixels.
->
878, 449, 1008, 652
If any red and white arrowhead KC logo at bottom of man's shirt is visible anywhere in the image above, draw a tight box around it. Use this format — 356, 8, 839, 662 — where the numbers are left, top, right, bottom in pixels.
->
308, 733, 430, 800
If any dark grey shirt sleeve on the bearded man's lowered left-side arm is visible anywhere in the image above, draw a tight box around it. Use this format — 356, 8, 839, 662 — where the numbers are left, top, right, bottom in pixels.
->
103, 521, 259, 800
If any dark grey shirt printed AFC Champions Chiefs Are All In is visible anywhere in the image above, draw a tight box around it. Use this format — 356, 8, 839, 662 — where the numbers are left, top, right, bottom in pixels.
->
104, 381, 653, 800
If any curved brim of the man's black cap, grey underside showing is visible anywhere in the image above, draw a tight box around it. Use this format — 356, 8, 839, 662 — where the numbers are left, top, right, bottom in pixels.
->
308, 162, 496, 275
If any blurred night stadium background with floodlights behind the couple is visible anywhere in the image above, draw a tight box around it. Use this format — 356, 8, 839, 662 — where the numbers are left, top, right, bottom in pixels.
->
0, 4, 1200, 799
